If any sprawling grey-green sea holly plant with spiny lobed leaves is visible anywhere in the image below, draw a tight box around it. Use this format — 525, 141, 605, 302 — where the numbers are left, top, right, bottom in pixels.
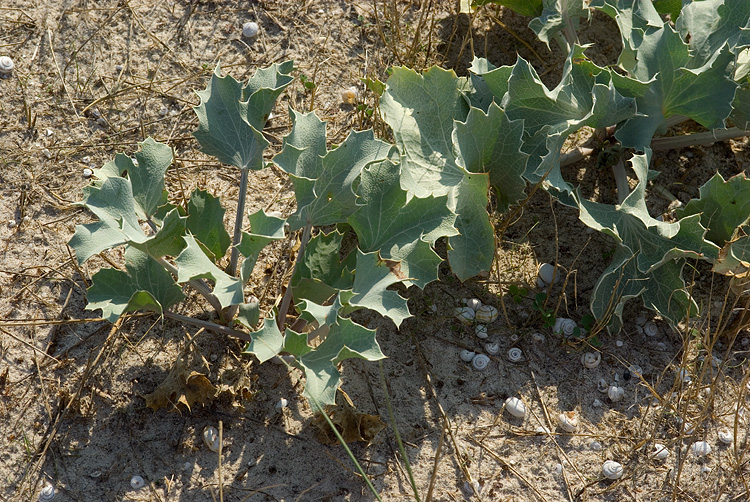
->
70, 0, 750, 405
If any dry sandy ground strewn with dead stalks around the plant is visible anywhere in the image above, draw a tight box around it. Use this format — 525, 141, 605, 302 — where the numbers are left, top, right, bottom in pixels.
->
0, 0, 750, 502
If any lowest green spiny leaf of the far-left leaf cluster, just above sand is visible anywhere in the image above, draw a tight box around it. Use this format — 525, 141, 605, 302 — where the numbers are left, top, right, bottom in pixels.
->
86, 247, 185, 322
